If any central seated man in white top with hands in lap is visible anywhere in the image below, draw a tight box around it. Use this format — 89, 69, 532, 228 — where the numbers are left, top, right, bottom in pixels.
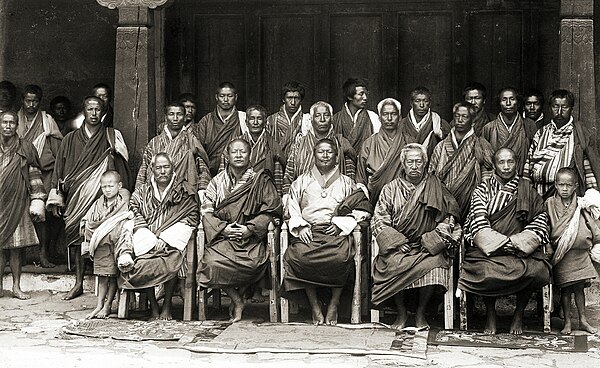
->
282, 138, 372, 325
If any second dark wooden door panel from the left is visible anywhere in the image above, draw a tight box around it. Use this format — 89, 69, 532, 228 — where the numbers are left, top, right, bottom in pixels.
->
260, 15, 316, 113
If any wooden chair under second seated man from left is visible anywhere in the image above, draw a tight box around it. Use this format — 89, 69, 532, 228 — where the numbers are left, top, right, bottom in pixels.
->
194, 219, 279, 322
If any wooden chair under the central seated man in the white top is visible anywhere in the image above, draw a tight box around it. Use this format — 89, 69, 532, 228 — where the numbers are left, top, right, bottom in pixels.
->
279, 222, 363, 323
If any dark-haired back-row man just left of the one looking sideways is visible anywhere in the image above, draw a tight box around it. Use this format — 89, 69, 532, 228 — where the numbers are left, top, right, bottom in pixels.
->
266, 81, 310, 154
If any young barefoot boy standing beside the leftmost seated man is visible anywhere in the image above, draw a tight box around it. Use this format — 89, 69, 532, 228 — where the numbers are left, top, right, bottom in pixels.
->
80, 170, 133, 319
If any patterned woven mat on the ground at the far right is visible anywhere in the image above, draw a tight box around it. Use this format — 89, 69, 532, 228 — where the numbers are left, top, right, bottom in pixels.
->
428, 330, 588, 352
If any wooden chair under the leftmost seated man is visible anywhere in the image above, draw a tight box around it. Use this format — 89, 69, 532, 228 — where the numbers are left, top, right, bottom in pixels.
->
118, 231, 197, 321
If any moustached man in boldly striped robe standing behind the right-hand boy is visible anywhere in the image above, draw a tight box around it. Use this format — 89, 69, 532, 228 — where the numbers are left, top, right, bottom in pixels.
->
523, 89, 600, 199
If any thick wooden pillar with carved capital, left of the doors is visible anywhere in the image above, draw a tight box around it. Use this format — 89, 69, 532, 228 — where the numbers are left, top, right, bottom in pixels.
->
96, 0, 168, 173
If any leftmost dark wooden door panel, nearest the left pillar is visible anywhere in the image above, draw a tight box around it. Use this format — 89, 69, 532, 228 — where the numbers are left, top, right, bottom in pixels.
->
194, 14, 246, 116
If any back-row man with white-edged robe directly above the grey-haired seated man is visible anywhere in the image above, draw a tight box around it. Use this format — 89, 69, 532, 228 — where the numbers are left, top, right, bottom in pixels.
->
400, 87, 450, 157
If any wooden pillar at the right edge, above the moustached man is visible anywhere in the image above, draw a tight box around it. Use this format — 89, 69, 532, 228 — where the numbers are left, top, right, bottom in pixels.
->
560, 0, 598, 129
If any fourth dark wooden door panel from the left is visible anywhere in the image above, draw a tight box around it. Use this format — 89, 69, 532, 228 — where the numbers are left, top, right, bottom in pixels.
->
398, 13, 453, 119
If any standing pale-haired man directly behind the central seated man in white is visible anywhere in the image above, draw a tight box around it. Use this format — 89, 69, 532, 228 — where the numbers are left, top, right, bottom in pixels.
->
283, 101, 356, 196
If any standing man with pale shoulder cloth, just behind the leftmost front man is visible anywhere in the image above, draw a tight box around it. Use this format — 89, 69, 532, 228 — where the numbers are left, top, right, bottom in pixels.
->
17, 84, 63, 268
